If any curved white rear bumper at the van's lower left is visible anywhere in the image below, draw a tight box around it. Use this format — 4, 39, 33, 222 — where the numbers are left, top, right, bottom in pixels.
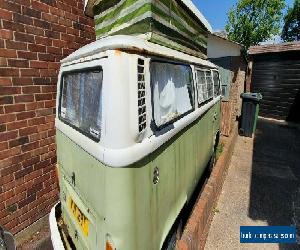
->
49, 202, 65, 250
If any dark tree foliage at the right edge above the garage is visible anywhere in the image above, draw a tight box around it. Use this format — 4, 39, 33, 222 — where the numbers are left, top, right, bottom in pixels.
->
281, 0, 300, 42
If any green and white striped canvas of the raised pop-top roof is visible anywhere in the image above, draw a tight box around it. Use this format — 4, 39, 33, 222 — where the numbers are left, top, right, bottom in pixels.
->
94, 0, 208, 59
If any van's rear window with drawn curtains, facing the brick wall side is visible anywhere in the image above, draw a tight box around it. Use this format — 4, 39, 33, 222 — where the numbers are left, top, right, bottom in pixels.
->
59, 68, 103, 141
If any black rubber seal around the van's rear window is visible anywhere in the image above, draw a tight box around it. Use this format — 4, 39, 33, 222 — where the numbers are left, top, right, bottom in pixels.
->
58, 65, 104, 143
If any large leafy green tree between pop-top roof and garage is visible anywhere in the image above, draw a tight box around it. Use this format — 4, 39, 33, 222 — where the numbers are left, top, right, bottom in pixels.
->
226, 0, 285, 49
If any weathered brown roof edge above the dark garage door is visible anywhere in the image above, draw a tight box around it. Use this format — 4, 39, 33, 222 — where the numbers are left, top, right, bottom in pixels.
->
248, 42, 300, 55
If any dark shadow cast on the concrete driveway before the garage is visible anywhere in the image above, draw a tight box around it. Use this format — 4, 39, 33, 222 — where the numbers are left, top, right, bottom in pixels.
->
249, 119, 300, 249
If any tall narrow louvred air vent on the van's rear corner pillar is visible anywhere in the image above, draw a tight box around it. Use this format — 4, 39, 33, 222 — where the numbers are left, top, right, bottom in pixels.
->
138, 59, 147, 133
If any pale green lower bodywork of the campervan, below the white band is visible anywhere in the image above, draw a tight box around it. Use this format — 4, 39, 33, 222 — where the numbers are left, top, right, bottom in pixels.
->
56, 102, 220, 250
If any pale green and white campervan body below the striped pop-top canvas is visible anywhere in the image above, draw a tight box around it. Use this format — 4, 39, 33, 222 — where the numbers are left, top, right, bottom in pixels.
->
50, 0, 221, 250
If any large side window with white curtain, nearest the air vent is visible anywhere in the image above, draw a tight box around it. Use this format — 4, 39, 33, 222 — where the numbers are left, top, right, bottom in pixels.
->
151, 61, 194, 127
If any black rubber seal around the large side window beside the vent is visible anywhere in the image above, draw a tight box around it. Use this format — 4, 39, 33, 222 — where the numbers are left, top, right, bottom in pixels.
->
149, 58, 196, 131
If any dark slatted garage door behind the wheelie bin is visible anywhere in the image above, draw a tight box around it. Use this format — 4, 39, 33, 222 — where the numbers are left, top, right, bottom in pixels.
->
251, 51, 300, 122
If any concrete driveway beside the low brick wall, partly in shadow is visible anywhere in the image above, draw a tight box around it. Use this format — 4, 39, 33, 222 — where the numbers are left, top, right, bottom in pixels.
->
205, 119, 300, 250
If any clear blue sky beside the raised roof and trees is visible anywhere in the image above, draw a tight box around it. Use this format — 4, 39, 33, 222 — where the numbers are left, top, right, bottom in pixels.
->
192, 0, 294, 31
